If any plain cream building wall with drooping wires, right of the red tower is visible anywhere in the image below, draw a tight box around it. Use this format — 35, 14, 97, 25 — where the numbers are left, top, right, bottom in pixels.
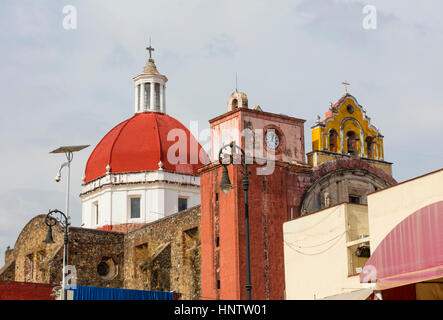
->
283, 204, 368, 300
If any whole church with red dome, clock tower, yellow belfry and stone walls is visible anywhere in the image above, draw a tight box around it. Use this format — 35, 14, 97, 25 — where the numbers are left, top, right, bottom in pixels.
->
0, 47, 396, 299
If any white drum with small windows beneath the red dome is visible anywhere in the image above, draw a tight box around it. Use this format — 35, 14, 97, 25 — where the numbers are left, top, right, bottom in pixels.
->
81, 172, 200, 228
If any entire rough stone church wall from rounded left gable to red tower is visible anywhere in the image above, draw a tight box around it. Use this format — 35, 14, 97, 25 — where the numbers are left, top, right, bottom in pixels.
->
0, 206, 201, 299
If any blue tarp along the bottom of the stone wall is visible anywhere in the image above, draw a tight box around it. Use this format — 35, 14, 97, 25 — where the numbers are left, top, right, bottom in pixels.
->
73, 286, 174, 300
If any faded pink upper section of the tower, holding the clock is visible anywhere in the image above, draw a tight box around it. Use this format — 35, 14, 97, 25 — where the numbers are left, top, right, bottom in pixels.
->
209, 91, 305, 163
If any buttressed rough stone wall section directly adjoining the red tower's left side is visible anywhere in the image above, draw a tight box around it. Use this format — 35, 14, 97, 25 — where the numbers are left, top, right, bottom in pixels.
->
124, 206, 201, 299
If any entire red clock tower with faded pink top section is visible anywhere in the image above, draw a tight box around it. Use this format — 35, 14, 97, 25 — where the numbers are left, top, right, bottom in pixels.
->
199, 90, 309, 300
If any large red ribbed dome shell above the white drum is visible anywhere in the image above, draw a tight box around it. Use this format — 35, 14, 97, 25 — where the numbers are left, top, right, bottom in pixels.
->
85, 112, 208, 183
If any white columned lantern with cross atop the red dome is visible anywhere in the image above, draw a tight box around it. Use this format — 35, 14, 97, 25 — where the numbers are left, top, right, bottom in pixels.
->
134, 45, 168, 113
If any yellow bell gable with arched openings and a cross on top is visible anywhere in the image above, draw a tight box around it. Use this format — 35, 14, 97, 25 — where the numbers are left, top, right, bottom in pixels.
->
307, 87, 392, 175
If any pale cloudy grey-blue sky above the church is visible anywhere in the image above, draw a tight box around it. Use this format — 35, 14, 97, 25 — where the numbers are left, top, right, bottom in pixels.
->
0, 0, 443, 266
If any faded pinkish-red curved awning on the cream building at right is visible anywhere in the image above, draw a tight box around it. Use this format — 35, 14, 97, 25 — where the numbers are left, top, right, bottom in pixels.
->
360, 201, 443, 290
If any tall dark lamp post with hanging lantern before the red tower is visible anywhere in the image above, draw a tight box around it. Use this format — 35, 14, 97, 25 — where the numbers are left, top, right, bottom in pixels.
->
218, 141, 252, 300
